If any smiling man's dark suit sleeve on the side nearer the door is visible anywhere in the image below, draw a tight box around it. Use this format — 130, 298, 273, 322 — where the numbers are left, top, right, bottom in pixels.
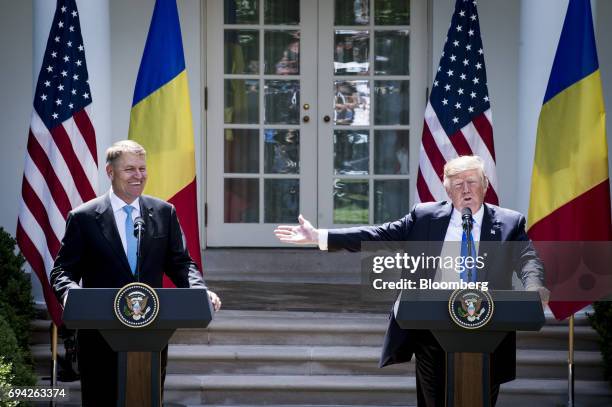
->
164, 206, 206, 288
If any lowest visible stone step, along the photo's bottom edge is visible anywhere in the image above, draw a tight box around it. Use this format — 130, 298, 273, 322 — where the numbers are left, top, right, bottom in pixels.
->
41, 375, 612, 407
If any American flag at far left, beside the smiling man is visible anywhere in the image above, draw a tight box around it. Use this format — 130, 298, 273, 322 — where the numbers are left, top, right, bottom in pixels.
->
17, 0, 98, 325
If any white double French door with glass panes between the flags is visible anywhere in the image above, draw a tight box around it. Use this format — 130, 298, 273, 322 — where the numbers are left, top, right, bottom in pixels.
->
205, 0, 427, 247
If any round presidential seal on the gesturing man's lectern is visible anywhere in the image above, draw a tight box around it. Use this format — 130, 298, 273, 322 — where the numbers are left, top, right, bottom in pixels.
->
448, 289, 495, 329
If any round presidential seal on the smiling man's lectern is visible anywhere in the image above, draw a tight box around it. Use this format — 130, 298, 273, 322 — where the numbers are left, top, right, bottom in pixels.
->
114, 283, 159, 328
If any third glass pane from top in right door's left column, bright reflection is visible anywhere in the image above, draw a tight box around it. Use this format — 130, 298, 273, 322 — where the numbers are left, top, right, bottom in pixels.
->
334, 80, 370, 126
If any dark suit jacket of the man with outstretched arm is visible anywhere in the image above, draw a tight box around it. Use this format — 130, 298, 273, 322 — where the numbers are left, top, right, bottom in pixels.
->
327, 201, 544, 384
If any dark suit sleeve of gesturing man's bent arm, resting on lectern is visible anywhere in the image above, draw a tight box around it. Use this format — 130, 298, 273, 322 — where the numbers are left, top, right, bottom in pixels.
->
513, 215, 544, 291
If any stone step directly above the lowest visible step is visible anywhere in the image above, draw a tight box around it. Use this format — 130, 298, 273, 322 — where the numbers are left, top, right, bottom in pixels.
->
32, 345, 603, 380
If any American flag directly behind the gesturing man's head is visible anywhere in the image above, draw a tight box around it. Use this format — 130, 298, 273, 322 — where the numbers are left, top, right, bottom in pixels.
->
416, 0, 498, 204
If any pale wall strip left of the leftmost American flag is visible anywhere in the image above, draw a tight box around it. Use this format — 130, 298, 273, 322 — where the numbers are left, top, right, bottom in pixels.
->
0, 0, 34, 236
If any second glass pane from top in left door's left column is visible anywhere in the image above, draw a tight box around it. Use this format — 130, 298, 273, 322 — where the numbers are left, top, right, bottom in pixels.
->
224, 30, 259, 74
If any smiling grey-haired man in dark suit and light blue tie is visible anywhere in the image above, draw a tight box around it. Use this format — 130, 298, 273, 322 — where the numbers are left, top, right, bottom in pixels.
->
51, 140, 221, 406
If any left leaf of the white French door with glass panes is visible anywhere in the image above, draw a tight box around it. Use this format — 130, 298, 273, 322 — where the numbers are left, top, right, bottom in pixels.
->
206, 0, 316, 246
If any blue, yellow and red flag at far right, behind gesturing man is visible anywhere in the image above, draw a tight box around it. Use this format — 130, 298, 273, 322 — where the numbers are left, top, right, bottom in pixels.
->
528, 0, 612, 319
